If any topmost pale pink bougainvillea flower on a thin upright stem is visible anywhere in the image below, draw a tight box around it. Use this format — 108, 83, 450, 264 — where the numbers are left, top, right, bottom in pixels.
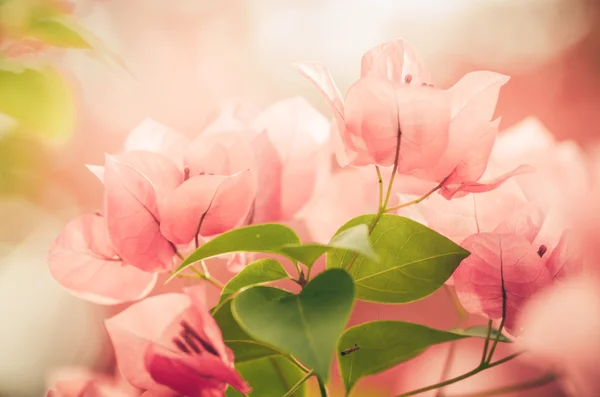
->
298, 40, 524, 199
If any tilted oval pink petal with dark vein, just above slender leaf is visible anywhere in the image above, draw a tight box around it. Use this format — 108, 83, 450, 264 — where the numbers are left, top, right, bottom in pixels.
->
161, 171, 256, 244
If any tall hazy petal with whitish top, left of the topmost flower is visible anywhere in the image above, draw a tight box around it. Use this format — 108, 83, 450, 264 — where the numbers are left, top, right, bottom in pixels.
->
252, 97, 330, 222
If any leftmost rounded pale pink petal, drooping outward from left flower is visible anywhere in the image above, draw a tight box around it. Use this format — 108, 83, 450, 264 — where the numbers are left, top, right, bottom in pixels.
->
48, 214, 157, 305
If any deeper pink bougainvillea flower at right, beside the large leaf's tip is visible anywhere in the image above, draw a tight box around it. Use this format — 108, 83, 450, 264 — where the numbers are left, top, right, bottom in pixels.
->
453, 210, 581, 334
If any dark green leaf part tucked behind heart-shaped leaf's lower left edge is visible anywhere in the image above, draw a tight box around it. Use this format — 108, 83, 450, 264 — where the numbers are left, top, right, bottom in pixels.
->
213, 301, 280, 363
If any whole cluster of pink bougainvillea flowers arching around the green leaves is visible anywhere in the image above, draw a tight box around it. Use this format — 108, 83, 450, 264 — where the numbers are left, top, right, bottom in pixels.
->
49, 40, 598, 397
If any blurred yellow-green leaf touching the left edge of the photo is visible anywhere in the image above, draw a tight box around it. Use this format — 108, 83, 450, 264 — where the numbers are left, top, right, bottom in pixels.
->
0, 68, 75, 142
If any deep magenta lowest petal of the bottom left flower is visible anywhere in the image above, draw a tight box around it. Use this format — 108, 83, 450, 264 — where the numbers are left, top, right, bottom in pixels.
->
145, 345, 251, 397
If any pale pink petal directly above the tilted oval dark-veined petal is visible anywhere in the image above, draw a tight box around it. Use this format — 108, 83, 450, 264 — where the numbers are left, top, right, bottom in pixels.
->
184, 126, 255, 176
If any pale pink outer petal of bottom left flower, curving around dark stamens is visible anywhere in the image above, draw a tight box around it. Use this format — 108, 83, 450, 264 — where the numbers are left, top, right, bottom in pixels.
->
105, 294, 190, 397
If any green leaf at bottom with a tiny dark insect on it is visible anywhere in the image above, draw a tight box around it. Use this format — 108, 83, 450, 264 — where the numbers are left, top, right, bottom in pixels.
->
337, 321, 467, 392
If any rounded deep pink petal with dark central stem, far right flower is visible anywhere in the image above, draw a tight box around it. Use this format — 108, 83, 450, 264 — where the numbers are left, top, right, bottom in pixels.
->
453, 233, 551, 333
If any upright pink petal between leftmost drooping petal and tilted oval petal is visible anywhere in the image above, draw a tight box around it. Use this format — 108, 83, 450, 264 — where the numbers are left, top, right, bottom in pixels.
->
104, 152, 182, 271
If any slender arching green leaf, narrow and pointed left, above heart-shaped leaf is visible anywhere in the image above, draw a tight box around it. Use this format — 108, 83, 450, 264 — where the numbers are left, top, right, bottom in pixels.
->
169, 223, 300, 280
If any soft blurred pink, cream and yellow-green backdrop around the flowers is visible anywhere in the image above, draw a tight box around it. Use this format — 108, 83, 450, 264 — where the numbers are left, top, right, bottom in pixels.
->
0, 0, 600, 397
